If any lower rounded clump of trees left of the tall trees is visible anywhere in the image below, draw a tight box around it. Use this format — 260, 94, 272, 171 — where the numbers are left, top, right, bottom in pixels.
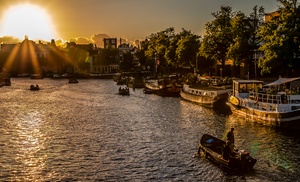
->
139, 28, 200, 74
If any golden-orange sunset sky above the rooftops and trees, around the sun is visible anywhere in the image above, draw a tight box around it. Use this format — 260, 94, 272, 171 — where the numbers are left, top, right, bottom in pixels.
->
0, 0, 280, 45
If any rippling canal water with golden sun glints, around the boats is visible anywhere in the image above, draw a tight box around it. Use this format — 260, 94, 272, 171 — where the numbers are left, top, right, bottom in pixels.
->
0, 78, 300, 182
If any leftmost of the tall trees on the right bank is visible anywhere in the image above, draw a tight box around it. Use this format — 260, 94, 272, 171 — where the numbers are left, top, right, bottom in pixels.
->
199, 6, 233, 74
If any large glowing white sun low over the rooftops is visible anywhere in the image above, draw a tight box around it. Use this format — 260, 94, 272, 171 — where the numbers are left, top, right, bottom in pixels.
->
0, 4, 56, 41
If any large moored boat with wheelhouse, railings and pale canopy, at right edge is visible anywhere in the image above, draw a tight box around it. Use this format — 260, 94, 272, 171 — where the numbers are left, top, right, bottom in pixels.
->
227, 77, 300, 129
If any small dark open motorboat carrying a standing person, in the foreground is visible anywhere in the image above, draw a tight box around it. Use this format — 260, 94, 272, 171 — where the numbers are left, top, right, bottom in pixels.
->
198, 134, 256, 171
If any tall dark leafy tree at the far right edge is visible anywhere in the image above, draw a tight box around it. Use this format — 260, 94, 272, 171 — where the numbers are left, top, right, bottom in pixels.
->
258, 0, 300, 76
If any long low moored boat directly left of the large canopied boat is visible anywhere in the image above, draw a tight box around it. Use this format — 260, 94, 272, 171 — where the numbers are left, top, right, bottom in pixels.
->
180, 84, 231, 107
